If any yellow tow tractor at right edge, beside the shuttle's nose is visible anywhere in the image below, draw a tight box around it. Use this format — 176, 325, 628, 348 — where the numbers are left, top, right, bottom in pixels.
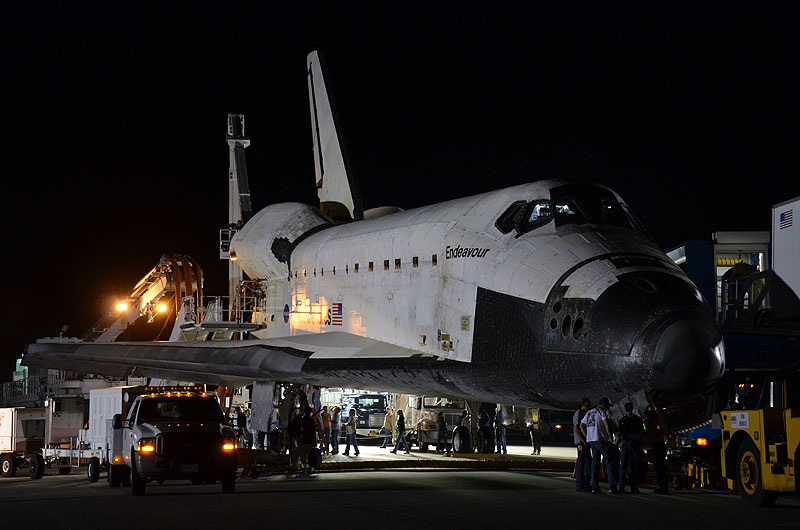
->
720, 373, 800, 506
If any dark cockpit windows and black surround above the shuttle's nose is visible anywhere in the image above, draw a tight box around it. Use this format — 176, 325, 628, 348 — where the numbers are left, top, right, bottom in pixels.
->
495, 184, 646, 237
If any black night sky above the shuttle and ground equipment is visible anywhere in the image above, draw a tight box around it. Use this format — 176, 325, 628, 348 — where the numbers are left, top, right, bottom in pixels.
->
0, 2, 800, 379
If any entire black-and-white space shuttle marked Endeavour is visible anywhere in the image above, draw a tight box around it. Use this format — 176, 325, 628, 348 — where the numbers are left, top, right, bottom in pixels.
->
24, 52, 725, 424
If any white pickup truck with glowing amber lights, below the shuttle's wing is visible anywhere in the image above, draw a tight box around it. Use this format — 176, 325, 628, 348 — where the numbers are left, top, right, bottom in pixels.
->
108, 387, 236, 495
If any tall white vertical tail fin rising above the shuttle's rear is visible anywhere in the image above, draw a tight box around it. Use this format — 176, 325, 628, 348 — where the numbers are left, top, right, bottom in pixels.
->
307, 51, 364, 221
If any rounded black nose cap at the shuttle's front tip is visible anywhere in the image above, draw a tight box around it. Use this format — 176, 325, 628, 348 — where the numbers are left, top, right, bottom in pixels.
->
653, 319, 725, 393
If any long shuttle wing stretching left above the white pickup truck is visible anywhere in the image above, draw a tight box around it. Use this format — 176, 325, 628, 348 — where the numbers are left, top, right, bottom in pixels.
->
24, 332, 422, 386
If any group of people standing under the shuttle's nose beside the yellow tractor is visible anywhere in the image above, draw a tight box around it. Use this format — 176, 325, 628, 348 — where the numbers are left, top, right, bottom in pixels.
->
572, 397, 669, 494
